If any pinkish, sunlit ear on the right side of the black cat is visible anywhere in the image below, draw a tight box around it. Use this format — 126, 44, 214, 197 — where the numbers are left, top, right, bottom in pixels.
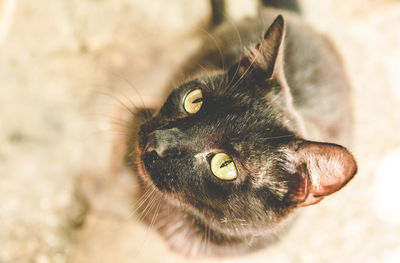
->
292, 141, 357, 206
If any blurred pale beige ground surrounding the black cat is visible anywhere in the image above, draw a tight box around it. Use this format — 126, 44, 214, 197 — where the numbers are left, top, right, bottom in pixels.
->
0, 0, 400, 263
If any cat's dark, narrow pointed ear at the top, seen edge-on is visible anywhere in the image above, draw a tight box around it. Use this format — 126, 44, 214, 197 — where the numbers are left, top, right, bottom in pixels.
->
229, 15, 285, 81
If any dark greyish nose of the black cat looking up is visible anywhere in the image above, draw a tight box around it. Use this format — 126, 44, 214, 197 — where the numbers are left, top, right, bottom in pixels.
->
145, 128, 183, 158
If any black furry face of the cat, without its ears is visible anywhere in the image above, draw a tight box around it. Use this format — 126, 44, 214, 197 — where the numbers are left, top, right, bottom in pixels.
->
140, 71, 298, 233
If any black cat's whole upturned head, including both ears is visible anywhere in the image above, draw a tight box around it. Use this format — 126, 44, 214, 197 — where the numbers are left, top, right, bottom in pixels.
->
134, 16, 357, 235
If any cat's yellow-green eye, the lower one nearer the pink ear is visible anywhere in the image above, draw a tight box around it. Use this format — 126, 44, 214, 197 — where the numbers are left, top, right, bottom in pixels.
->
211, 153, 237, 180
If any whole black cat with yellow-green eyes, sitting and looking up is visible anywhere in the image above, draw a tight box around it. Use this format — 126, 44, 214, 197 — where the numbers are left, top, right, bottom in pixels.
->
126, 0, 357, 257
